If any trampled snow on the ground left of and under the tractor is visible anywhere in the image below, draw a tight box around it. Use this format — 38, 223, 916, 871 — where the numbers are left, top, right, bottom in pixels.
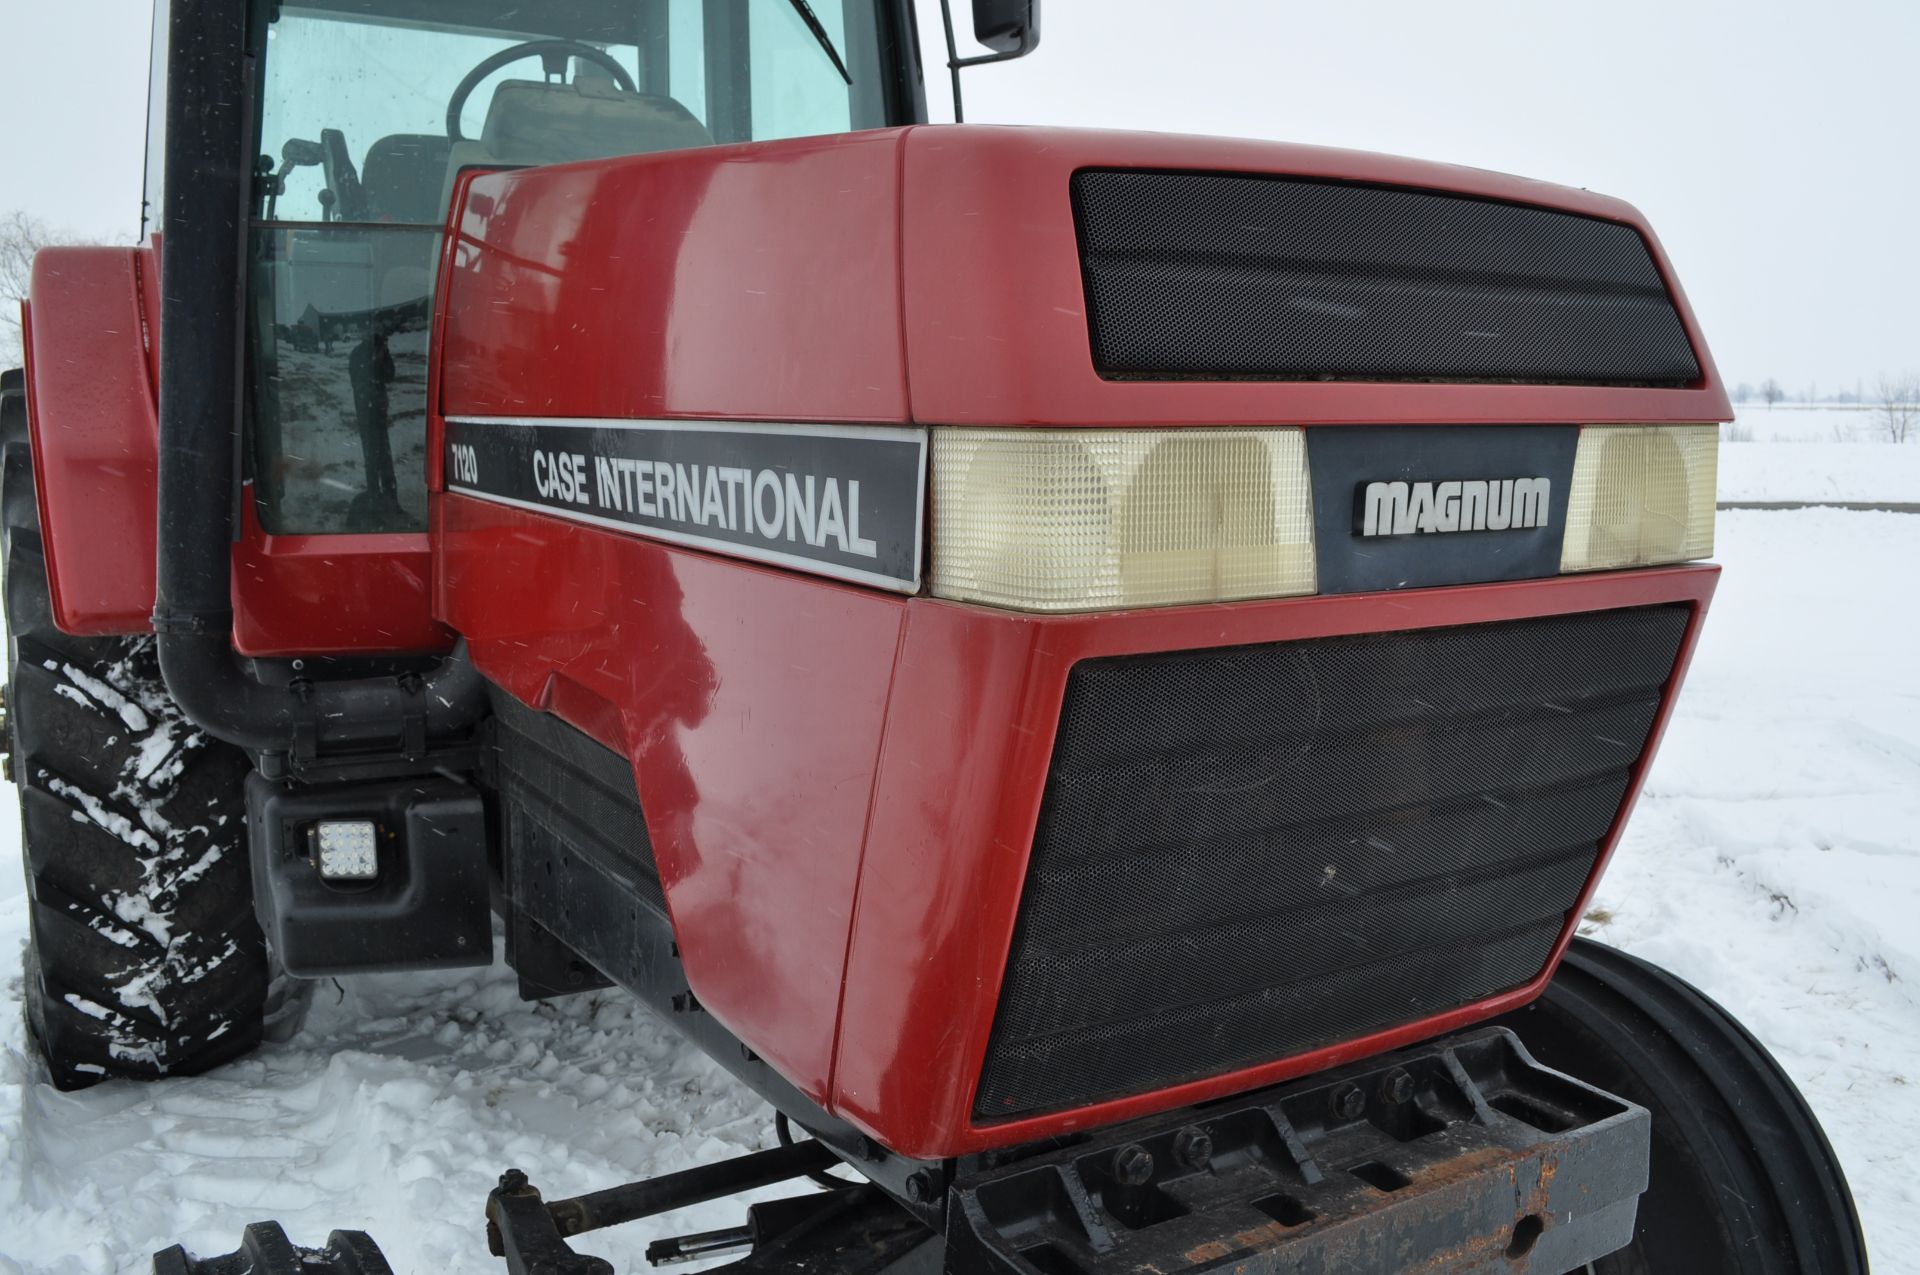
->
0, 883, 798, 1275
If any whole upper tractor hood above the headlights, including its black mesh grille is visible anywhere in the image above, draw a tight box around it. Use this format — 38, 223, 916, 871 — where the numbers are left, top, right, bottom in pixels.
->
440, 127, 1726, 426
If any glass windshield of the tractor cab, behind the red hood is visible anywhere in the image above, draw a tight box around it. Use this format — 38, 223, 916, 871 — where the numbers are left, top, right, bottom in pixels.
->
248, 0, 889, 534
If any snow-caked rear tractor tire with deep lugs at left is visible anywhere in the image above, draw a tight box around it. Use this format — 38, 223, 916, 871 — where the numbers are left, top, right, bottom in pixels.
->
0, 373, 267, 1089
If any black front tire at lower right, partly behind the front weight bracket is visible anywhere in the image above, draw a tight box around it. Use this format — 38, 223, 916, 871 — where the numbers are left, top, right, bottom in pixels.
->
1498, 939, 1866, 1275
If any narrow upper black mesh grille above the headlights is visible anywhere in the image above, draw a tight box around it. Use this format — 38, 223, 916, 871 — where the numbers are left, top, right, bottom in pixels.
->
1073, 171, 1699, 386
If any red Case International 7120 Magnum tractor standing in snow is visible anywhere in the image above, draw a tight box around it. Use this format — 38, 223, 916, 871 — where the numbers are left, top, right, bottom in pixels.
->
0, 0, 1866, 1275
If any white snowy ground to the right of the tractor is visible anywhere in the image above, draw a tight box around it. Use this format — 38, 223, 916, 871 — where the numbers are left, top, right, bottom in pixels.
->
1586, 506, 1920, 1275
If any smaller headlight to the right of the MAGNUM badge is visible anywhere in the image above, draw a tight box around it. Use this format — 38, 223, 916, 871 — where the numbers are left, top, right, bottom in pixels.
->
1561, 424, 1720, 570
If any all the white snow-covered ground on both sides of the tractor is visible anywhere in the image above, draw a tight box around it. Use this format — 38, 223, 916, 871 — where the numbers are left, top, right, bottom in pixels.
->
0, 506, 1920, 1275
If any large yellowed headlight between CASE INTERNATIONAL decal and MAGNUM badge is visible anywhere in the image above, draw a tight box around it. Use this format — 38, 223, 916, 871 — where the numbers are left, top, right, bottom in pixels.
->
929, 428, 1313, 611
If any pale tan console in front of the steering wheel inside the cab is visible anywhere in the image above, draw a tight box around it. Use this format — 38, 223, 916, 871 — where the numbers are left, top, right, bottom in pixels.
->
440, 77, 714, 209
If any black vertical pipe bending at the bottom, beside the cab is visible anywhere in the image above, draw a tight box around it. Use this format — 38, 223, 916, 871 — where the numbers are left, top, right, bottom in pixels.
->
154, 0, 486, 755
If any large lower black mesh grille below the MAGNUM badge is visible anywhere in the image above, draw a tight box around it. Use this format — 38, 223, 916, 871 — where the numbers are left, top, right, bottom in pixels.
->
975, 607, 1688, 1118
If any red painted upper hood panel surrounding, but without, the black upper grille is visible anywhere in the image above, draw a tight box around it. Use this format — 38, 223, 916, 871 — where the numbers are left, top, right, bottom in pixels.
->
444, 125, 1728, 433
